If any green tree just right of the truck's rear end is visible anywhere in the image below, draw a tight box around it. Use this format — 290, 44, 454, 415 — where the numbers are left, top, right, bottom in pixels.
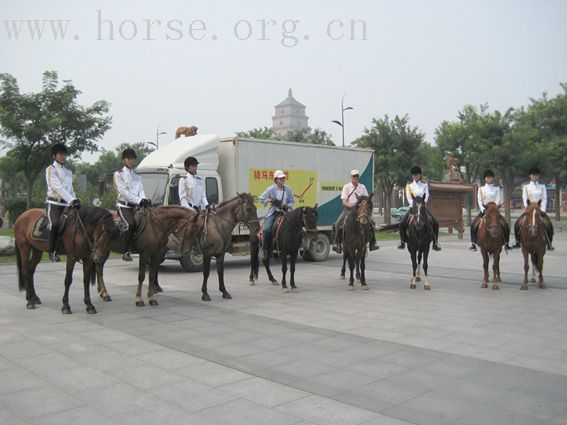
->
353, 115, 425, 223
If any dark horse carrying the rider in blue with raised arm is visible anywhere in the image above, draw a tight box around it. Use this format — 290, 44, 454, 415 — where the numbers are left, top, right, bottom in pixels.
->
250, 205, 319, 293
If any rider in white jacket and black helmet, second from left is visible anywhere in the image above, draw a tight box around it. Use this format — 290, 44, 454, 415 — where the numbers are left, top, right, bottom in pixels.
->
114, 148, 152, 261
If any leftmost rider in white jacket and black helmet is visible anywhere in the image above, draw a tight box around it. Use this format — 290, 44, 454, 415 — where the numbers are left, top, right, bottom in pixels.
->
45, 143, 81, 262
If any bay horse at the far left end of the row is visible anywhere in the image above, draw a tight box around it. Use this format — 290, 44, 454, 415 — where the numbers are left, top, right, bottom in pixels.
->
14, 207, 118, 314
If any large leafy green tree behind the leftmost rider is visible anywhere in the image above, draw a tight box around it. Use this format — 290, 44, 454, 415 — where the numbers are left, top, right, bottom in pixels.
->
0, 71, 112, 208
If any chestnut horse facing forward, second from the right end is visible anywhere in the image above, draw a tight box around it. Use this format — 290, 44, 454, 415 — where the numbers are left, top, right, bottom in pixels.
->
476, 202, 505, 289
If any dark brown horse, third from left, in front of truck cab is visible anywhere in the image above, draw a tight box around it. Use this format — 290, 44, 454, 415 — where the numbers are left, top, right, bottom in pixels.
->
197, 193, 259, 301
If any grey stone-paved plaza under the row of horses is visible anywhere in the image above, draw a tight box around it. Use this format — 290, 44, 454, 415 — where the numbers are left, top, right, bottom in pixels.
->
0, 232, 567, 425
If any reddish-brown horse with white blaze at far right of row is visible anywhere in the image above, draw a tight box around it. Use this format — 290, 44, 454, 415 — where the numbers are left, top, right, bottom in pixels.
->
520, 201, 547, 290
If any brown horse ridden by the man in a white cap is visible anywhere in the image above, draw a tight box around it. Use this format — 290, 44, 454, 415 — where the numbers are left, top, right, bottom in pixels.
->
339, 196, 372, 290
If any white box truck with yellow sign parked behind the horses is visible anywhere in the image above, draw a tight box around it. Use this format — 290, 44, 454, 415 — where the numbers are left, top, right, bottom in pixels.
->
136, 134, 374, 271
